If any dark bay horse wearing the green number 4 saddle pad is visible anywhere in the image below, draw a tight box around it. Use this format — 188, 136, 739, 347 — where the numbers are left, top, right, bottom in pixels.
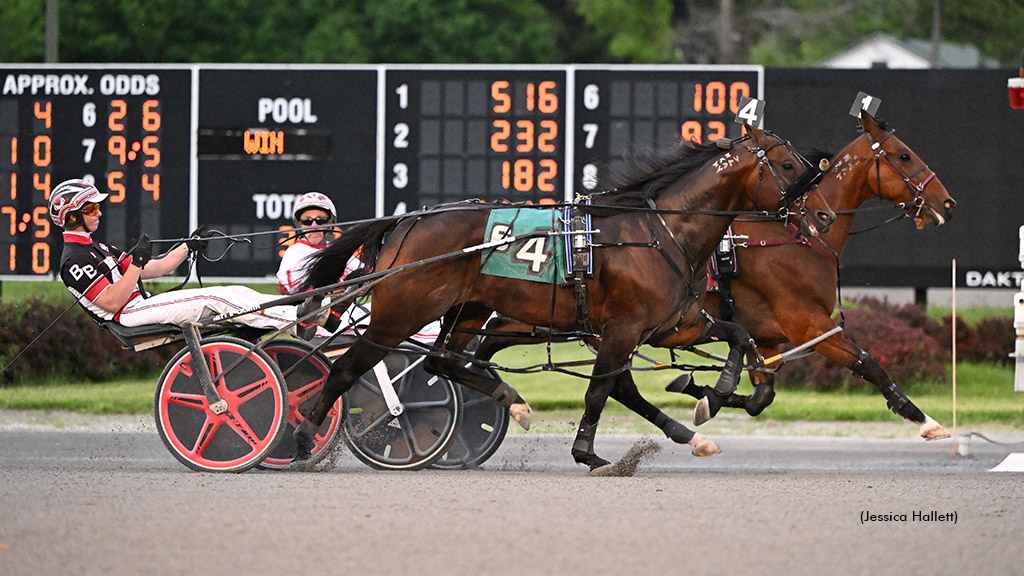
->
295, 127, 834, 471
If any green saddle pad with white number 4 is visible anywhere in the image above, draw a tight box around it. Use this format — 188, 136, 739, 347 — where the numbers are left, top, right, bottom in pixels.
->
480, 208, 566, 284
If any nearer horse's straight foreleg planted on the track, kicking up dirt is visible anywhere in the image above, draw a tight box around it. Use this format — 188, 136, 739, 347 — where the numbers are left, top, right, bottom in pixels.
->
571, 329, 640, 475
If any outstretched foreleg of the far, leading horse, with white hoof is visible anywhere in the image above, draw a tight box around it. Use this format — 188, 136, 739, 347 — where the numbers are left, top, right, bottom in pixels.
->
814, 334, 949, 440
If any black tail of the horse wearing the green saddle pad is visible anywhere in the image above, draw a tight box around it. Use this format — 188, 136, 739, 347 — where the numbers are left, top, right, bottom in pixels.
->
301, 219, 397, 290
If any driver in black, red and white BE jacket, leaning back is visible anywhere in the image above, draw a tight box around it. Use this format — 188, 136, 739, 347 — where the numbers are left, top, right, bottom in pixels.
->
49, 175, 319, 339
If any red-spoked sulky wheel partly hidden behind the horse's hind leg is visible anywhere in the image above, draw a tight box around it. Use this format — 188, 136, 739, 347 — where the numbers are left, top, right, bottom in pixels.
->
260, 338, 345, 469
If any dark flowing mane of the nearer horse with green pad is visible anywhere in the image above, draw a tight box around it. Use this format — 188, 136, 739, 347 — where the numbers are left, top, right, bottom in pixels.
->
589, 140, 723, 212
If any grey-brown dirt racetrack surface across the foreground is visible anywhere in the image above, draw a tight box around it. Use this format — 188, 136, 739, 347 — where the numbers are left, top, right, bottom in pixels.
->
0, 416, 1024, 576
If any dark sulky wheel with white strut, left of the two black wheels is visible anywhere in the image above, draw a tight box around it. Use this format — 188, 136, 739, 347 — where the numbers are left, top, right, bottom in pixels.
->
342, 342, 461, 470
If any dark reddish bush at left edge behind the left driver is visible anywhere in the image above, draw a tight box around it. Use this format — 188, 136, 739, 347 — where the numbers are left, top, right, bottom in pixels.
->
0, 298, 177, 385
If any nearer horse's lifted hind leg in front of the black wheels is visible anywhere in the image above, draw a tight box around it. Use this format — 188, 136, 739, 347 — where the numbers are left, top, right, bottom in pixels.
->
424, 304, 532, 430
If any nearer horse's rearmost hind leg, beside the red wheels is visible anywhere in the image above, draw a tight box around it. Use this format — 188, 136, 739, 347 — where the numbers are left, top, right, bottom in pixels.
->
292, 338, 388, 465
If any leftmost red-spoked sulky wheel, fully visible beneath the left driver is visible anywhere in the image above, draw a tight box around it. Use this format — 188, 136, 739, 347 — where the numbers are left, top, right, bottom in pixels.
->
154, 337, 288, 472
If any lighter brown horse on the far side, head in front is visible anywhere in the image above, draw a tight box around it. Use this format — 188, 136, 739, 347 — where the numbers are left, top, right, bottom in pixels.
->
688, 112, 956, 440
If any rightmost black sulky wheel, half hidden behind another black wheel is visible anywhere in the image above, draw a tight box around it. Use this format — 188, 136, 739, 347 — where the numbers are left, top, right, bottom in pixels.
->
430, 366, 509, 470
